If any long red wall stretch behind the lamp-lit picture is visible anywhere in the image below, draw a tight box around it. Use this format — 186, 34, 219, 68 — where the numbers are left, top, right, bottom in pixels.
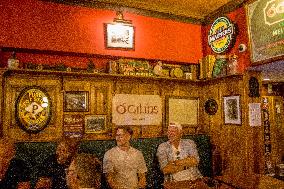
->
0, 0, 202, 63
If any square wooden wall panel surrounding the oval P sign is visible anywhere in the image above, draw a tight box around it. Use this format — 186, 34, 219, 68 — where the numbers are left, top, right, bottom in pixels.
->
3, 75, 62, 141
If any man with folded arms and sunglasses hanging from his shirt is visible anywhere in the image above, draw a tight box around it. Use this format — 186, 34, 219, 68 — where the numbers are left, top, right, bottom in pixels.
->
157, 123, 203, 188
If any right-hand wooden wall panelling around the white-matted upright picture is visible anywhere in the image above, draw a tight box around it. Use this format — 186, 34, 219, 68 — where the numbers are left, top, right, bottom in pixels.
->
202, 76, 251, 185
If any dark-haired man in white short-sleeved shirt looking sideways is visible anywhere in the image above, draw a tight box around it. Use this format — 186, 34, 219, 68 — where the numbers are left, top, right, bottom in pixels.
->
103, 127, 147, 189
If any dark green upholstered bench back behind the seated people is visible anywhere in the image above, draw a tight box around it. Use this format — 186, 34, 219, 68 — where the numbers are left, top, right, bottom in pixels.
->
16, 135, 212, 189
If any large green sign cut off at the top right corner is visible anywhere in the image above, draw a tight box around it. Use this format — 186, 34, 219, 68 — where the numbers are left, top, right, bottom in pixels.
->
247, 0, 284, 62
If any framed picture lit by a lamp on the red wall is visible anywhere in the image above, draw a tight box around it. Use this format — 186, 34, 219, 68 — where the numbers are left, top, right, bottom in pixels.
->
104, 23, 135, 50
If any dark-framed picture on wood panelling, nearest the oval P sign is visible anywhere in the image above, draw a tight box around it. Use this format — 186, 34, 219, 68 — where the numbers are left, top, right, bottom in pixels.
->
64, 91, 89, 112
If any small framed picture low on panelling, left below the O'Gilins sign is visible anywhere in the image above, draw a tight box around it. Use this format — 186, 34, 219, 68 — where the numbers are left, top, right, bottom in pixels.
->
85, 115, 107, 133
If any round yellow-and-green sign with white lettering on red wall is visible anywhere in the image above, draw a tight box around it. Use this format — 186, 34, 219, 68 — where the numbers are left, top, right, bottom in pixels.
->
208, 17, 235, 53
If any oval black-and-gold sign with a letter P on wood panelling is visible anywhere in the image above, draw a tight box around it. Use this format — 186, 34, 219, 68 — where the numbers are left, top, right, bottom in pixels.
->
16, 86, 51, 133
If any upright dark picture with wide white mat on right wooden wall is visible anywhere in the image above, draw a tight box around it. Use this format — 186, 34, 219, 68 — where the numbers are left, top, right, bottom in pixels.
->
223, 95, 241, 125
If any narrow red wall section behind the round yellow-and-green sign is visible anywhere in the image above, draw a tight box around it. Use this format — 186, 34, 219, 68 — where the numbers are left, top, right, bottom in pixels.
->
202, 7, 250, 72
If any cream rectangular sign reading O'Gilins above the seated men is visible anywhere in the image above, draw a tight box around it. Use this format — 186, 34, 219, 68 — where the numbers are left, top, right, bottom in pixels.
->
112, 94, 162, 125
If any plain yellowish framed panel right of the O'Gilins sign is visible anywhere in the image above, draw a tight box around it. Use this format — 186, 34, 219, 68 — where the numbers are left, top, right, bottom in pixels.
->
166, 96, 199, 126
